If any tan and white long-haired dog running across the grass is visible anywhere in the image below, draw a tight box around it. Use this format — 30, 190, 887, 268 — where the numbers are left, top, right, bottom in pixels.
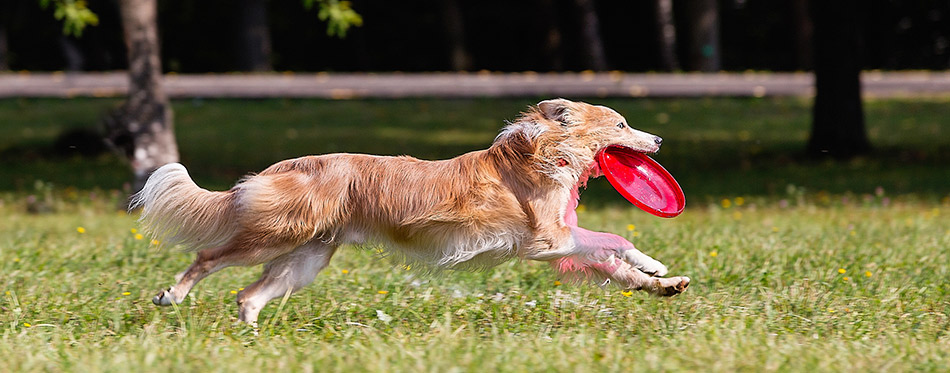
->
130, 99, 690, 324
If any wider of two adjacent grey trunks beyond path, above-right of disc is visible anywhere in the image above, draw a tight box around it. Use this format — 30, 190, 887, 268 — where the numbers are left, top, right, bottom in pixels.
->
686, 0, 722, 72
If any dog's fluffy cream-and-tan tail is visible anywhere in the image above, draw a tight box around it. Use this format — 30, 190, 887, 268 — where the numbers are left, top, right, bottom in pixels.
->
129, 163, 236, 250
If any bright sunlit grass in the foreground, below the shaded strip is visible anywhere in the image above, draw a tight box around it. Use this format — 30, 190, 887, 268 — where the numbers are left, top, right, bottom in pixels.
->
0, 195, 950, 371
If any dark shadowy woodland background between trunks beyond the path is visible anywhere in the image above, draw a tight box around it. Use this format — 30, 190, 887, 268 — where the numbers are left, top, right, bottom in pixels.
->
0, 0, 950, 73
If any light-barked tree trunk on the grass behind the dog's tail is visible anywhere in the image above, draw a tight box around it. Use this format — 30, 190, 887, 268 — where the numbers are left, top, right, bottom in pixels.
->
105, 0, 178, 196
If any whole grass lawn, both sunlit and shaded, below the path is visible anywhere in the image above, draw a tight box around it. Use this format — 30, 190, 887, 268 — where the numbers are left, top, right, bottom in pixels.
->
0, 99, 950, 372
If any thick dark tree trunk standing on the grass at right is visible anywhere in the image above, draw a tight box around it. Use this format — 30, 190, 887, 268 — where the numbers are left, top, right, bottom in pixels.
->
808, 0, 871, 158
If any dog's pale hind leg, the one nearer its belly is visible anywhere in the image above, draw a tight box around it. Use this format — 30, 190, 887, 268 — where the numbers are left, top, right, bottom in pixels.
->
237, 240, 336, 324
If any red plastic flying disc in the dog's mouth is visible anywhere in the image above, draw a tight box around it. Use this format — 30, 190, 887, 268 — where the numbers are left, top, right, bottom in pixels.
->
597, 145, 686, 218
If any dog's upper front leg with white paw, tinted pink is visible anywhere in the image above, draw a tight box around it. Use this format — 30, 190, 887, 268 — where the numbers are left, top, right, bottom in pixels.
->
571, 227, 667, 276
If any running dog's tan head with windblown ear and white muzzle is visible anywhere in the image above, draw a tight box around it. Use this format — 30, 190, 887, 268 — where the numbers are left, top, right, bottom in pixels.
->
495, 99, 663, 185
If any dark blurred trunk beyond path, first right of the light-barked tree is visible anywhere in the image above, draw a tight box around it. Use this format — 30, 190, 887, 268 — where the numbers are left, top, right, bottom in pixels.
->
235, 0, 273, 71
